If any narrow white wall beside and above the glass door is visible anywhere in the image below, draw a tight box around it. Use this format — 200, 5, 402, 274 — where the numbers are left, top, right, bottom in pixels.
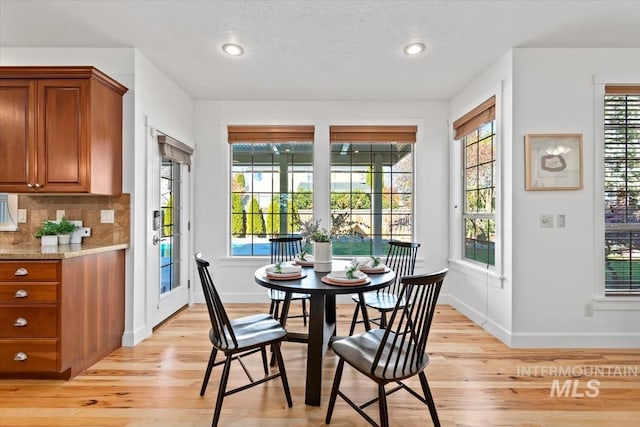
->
131, 50, 196, 345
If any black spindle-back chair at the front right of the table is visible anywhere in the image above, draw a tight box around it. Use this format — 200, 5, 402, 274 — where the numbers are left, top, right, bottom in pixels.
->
325, 269, 447, 427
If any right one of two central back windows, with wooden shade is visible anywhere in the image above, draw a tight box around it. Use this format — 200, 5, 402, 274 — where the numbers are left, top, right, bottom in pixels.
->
330, 126, 416, 255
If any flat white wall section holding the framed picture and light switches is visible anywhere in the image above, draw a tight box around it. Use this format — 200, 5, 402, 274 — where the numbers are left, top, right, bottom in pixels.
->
512, 49, 640, 347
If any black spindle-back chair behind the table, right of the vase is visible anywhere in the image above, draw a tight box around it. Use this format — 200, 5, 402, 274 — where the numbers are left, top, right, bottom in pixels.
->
349, 240, 420, 335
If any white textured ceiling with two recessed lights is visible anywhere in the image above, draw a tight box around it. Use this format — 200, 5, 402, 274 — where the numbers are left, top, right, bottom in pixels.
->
0, 0, 640, 100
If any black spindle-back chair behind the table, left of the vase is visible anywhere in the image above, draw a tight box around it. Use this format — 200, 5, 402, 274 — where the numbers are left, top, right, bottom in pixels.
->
267, 236, 311, 326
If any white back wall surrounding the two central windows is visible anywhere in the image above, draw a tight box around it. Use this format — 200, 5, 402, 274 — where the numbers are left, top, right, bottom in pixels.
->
194, 101, 448, 302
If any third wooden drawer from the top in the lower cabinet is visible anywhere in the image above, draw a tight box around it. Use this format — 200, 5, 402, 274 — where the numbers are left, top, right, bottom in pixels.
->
0, 305, 58, 338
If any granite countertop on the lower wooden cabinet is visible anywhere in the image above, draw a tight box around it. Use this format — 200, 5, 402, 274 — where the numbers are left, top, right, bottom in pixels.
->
0, 243, 129, 260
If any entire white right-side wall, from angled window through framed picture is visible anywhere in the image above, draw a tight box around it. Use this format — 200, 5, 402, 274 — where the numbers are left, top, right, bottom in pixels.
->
447, 49, 640, 348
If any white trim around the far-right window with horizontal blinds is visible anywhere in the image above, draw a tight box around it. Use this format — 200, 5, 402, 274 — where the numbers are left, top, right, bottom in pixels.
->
591, 75, 640, 311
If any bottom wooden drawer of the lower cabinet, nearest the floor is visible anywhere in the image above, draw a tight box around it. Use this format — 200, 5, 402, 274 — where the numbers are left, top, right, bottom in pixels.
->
0, 339, 58, 372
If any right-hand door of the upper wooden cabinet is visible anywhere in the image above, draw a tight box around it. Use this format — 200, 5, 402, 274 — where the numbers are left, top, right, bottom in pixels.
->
36, 79, 89, 193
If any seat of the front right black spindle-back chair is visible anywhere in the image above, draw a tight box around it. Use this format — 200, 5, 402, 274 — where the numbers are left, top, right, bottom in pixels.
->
331, 329, 429, 381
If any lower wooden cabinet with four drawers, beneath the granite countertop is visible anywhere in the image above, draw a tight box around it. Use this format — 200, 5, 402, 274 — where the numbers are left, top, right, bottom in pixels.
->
0, 250, 125, 379
